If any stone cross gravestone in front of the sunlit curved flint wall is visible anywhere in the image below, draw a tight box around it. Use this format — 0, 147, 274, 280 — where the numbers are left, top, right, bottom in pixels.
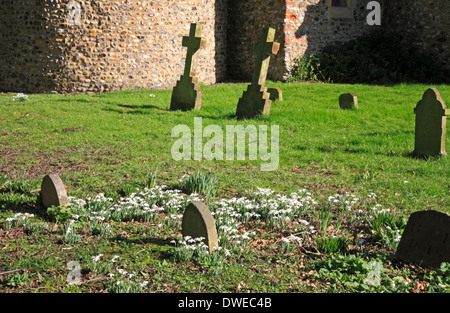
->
170, 24, 206, 111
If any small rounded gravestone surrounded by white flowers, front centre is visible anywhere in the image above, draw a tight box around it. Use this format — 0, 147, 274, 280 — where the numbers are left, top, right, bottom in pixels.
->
181, 201, 219, 252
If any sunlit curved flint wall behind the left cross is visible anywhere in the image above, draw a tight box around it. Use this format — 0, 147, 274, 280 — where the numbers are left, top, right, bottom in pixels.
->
0, 0, 226, 92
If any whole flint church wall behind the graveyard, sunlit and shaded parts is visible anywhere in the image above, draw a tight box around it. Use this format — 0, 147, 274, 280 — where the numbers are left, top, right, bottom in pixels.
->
0, 0, 450, 93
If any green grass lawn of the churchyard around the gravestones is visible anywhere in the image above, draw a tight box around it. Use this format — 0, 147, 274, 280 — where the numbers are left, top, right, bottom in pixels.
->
0, 82, 450, 292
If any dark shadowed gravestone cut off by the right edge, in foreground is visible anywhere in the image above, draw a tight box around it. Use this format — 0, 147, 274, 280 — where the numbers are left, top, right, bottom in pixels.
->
395, 210, 450, 267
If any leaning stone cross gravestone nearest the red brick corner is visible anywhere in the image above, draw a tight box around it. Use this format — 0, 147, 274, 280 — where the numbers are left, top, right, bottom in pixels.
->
236, 28, 280, 119
